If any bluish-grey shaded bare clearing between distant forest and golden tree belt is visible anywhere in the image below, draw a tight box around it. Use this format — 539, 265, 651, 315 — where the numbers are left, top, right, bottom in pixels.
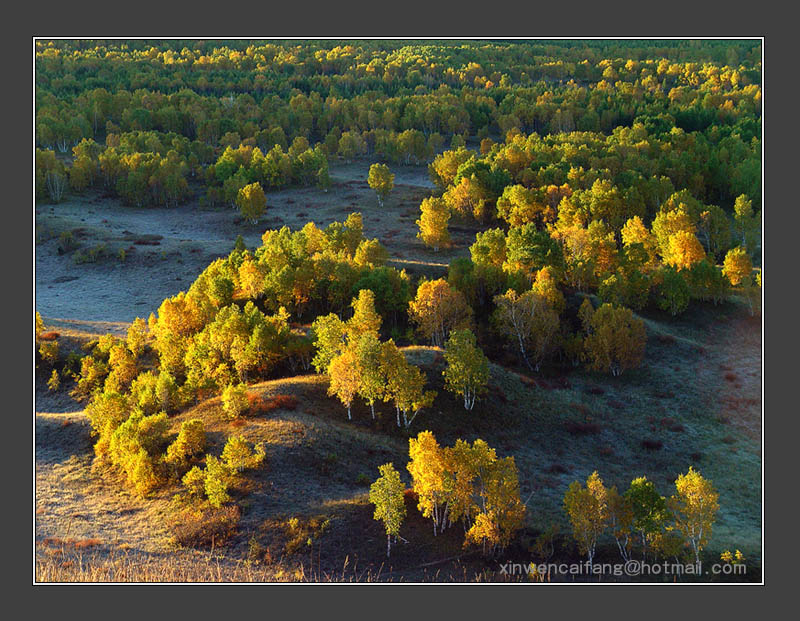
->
35, 160, 450, 330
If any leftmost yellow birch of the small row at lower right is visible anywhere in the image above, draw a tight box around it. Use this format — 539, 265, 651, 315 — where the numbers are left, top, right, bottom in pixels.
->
564, 472, 609, 565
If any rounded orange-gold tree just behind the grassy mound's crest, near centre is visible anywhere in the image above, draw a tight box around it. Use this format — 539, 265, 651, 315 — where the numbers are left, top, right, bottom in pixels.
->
408, 278, 472, 347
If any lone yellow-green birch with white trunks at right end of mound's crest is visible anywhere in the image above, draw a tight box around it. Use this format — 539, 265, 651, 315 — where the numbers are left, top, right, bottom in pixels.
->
442, 330, 489, 411
